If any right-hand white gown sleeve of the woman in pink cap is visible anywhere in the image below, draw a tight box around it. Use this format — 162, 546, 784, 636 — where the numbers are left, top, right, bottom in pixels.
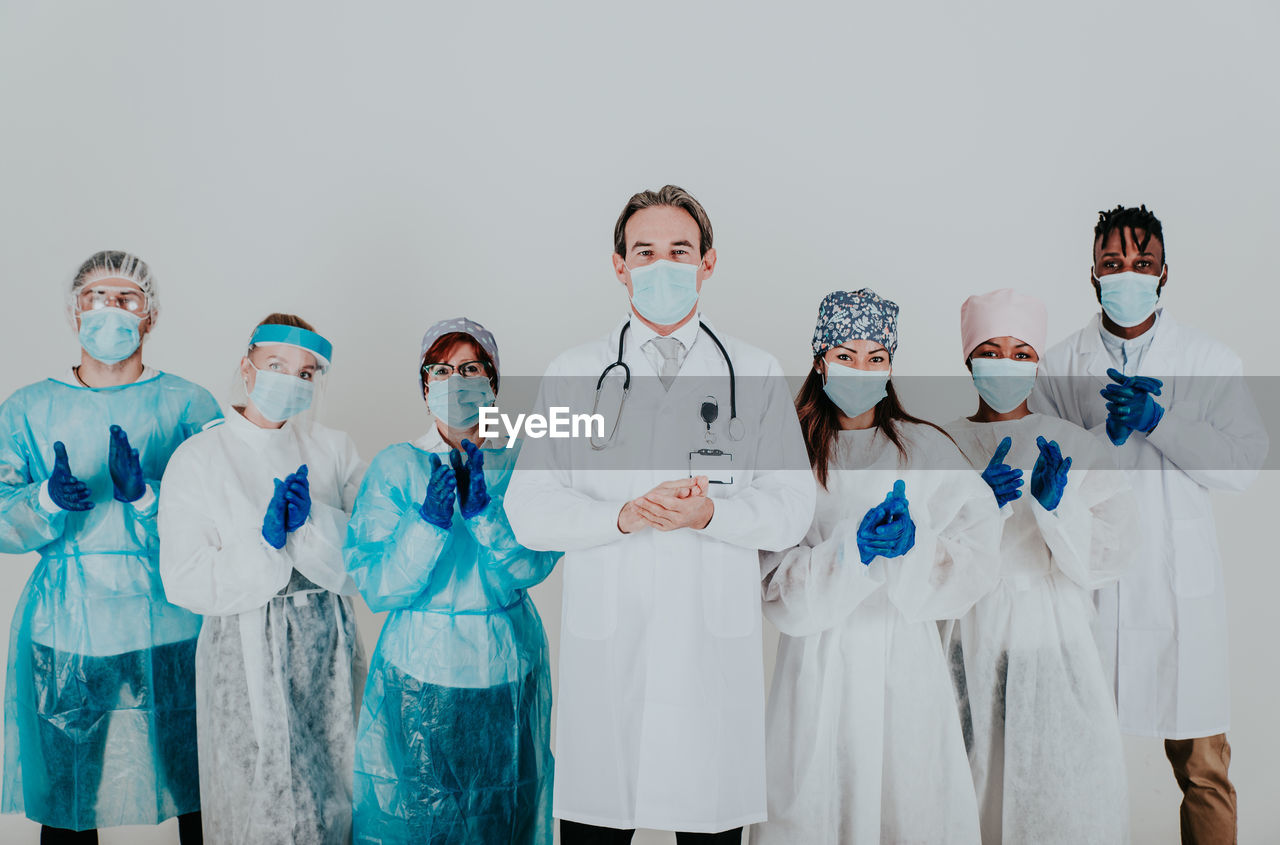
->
1025, 439, 1139, 590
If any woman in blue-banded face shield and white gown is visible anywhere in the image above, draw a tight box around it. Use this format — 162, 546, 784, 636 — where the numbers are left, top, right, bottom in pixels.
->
160, 314, 365, 845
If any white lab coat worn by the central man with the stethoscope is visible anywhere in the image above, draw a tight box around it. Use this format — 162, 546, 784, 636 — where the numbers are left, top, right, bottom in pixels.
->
506, 312, 814, 832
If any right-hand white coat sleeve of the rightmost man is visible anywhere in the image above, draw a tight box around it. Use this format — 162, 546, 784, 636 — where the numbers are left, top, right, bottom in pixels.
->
1147, 356, 1270, 492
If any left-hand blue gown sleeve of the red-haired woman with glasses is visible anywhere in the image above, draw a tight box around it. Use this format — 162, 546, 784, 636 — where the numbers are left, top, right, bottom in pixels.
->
343, 447, 458, 613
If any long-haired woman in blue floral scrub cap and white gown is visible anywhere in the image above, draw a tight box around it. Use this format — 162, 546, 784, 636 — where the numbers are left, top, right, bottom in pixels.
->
751, 289, 1001, 845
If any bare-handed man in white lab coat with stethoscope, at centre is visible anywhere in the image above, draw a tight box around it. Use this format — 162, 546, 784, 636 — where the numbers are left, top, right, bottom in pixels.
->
506, 186, 814, 845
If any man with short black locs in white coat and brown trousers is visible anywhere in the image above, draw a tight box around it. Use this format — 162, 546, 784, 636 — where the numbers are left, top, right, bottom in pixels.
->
1032, 206, 1267, 844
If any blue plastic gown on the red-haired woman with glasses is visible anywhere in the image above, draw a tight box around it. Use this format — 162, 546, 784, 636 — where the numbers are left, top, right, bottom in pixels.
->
346, 426, 559, 845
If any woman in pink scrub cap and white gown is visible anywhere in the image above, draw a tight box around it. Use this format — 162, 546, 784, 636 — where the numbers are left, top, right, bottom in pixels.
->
946, 288, 1137, 845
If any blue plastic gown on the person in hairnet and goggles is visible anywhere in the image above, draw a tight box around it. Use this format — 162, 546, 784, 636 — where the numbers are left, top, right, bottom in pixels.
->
0, 370, 221, 830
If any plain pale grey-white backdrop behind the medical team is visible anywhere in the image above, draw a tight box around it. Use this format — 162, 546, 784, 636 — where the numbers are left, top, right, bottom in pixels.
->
0, 0, 1280, 842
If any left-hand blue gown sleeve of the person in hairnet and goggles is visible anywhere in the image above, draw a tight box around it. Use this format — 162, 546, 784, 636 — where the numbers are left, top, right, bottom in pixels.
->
0, 397, 67, 554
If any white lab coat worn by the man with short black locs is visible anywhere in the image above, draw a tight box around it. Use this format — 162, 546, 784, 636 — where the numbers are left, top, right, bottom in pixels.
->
1032, 311, 1267, 739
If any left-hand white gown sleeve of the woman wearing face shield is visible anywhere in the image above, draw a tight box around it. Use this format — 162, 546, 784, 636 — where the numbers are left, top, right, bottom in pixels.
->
159, 444, 289, 616
